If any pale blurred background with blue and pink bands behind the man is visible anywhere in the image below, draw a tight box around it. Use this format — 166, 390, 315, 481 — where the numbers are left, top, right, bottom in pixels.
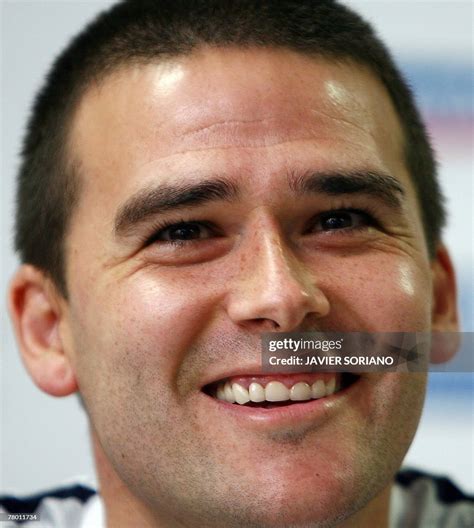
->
0, 0, 474, 494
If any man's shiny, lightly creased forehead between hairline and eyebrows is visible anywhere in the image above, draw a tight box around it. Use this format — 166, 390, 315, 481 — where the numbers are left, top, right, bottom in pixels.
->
71, 49, 402, 217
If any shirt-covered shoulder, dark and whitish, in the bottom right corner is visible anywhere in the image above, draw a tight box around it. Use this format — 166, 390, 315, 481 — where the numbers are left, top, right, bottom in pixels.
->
390, 469, 474, 528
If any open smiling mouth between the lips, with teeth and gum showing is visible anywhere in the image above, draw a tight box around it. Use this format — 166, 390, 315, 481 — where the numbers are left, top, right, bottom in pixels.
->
202, 372, 360, 410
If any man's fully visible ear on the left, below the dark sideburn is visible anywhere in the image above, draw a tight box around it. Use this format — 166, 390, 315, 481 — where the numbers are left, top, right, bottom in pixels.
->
8, 265, 78, 396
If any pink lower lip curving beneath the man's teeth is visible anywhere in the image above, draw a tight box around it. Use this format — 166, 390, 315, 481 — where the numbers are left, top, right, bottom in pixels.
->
206, 377, 363, 428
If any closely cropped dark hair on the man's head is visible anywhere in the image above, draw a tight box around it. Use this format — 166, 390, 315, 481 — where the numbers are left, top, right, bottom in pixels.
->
15, 0, 445, 297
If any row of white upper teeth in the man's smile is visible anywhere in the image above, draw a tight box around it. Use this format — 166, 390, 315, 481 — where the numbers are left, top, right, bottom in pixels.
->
216, 377, 340, 405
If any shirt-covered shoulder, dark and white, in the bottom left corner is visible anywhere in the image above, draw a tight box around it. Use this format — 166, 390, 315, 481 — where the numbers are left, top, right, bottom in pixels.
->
0, 484, 98, 528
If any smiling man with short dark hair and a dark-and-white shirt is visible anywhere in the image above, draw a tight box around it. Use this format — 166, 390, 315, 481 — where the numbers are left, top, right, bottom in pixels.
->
4, 1, 472, 528
